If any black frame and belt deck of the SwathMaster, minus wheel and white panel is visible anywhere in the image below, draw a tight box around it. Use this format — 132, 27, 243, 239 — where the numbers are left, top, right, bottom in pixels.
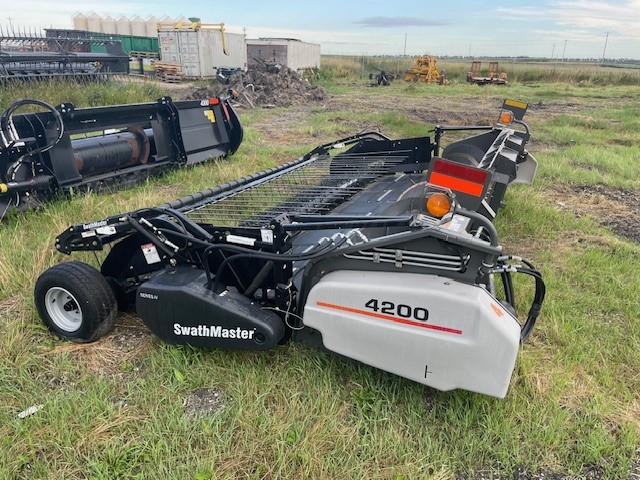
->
33, 100, 545, 368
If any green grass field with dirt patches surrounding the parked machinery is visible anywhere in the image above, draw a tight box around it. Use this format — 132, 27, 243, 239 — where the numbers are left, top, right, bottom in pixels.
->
0, 69, 640, 480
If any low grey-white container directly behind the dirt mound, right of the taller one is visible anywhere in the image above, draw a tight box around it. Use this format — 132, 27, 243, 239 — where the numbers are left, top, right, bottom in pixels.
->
247, 38, 320, 71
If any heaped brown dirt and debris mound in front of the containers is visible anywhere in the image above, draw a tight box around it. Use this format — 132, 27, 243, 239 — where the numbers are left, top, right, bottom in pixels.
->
187, 63, 327, 107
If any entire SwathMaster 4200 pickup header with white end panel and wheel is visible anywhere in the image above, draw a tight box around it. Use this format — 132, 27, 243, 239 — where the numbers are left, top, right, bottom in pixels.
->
34, 100, 545, 397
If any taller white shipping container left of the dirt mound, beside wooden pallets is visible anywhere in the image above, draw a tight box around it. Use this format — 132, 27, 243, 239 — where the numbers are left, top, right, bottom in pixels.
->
158, 27, 247, 78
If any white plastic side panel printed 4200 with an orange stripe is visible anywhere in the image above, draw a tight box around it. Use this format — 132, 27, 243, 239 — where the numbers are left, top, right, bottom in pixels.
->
304, 271, 520, 398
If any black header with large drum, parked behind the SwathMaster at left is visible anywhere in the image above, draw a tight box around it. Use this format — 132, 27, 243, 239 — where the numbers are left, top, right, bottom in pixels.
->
0, 97, 243, 219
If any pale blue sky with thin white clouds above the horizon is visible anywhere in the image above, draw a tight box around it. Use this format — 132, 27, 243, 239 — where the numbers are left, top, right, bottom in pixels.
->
0, 0, 640, 59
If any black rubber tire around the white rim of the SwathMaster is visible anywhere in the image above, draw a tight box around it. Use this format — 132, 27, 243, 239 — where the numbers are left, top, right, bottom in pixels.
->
34, 262, 118, 343
